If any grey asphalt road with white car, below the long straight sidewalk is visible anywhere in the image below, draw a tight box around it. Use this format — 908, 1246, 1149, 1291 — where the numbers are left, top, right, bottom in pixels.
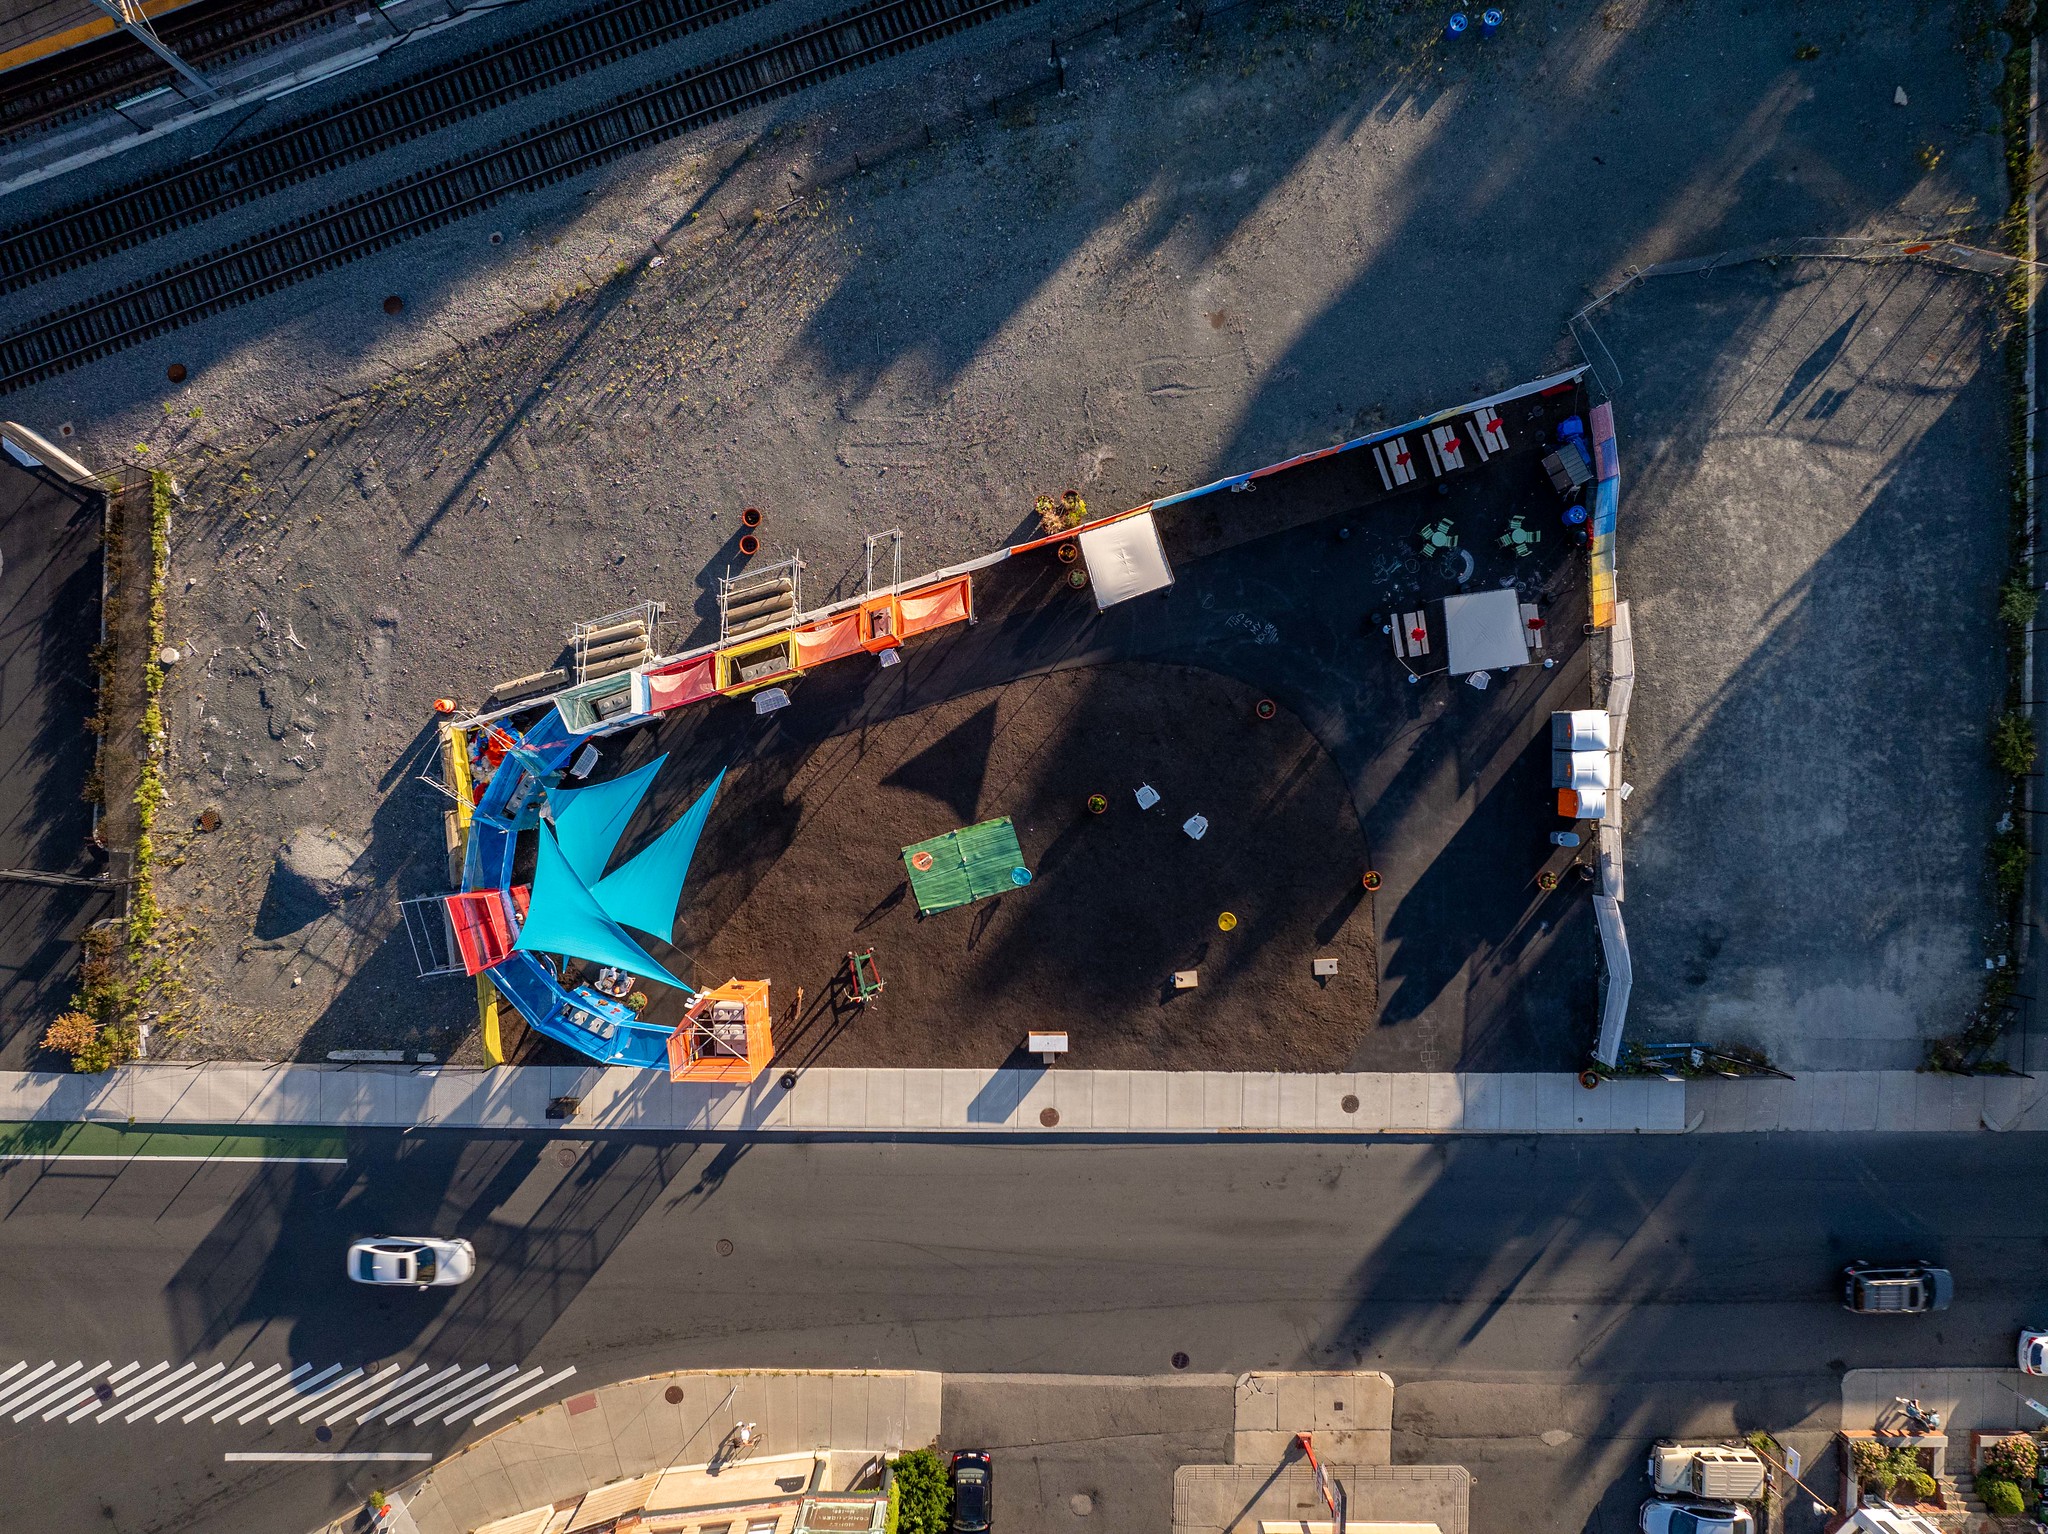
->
0, 1133, 2048, 1534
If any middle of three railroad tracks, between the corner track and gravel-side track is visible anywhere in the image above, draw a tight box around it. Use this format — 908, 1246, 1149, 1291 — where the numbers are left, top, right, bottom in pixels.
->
0, 0, 790, 293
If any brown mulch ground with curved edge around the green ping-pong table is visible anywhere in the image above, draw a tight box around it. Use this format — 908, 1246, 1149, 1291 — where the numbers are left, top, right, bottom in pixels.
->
614, 662, 1376, 1071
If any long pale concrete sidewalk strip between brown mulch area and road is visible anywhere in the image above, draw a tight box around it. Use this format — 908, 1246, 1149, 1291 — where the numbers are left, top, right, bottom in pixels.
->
0, 1065, 1686, 1135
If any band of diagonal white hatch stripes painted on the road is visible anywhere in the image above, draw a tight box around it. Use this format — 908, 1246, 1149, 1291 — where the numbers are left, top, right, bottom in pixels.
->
0, 1358, 575, 1428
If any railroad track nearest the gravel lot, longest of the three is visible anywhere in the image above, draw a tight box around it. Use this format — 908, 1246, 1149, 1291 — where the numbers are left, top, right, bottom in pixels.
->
0, 0, 1032, 393
